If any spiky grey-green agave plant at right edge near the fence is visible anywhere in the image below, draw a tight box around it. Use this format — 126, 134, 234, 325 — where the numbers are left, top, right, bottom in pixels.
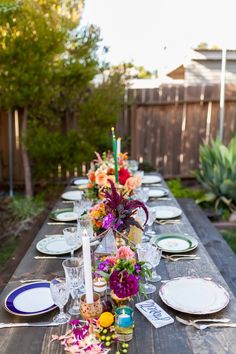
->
195, 137, 236, 211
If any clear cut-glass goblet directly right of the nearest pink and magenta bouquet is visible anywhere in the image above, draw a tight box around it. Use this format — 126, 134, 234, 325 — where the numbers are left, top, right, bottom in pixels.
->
137, 243, 159, 295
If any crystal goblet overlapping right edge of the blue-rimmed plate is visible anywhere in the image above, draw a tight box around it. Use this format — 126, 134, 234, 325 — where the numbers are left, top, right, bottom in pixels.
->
50, 278, 71, 324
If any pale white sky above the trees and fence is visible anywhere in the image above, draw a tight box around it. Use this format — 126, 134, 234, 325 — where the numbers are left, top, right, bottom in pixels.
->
82, 0, 236, 71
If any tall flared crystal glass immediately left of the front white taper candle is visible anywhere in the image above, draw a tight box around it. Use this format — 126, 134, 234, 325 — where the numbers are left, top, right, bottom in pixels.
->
62, 257, 84, 315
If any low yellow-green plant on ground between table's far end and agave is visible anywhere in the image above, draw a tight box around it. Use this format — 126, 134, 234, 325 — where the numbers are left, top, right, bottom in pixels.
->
167, 178, 203, 200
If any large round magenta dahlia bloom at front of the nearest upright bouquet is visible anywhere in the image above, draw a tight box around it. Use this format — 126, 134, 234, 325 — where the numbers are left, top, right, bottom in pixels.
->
110, 269, 140, 299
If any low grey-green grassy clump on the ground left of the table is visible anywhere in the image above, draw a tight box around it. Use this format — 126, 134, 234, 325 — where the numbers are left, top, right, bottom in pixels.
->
8, 196, 44, 220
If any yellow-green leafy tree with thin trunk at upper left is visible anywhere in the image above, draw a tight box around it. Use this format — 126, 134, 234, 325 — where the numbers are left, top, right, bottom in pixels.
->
0, 0, 83, 197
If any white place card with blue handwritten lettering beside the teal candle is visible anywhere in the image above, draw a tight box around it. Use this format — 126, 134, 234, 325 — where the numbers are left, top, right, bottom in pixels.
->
135, 299, 174, 328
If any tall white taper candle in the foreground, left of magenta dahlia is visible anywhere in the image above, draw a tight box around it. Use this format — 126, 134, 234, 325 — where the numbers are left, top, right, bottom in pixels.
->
82, 230, 93, 304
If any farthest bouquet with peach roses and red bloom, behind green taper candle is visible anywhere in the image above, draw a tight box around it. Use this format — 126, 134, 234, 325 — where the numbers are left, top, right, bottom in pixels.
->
86, 151, 141, 199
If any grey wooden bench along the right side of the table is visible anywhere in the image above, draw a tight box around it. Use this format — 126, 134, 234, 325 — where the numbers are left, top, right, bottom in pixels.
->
178, 199, 236, 295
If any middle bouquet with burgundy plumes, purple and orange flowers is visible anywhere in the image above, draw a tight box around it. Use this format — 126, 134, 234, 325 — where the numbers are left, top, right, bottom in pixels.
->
89, 179, 148, 232
